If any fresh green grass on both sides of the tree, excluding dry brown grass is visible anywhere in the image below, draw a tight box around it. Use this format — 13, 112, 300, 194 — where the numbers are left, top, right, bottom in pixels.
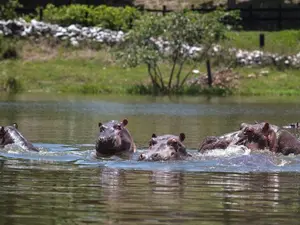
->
0, 59, 300, 96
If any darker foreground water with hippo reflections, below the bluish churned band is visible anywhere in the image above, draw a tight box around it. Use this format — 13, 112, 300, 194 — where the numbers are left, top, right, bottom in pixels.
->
0, 163, 300, 224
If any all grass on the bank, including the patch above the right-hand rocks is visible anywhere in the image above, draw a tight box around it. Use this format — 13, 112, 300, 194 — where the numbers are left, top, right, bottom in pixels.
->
0, 31, 300, 95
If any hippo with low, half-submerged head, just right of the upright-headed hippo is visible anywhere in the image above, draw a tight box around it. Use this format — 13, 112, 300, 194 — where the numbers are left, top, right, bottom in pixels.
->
138, 133, 190, 161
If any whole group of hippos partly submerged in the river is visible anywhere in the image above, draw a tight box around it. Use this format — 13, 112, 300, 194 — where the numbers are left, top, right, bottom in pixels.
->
0, 119, 300, 161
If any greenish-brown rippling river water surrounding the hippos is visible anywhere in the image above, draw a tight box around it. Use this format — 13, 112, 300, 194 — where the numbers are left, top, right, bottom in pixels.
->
0, 94, 300, 225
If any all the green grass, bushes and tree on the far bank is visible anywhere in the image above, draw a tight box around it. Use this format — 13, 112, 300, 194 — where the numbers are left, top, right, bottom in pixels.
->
0, 0, 300, 95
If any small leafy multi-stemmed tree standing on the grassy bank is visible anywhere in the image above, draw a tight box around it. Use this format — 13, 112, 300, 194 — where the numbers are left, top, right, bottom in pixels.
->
117, 11, 231, 94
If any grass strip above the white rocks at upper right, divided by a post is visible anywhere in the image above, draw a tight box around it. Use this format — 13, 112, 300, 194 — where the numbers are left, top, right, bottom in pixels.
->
222, 30, 300, 55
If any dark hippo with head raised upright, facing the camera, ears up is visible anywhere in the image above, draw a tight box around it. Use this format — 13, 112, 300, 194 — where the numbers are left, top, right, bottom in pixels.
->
96, 119, 136, 157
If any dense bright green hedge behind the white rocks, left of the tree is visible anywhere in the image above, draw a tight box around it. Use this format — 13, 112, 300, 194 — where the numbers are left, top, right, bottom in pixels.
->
44, 4, 140, 30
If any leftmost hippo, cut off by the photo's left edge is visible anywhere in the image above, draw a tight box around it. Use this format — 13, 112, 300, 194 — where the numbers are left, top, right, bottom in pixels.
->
0, 123, 39, 152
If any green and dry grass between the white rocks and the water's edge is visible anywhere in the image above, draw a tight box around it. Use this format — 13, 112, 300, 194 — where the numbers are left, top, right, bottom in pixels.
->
0, 39, 300, 96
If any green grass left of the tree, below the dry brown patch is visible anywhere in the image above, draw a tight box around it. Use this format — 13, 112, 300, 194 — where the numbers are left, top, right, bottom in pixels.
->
0, 59, 147, 94
